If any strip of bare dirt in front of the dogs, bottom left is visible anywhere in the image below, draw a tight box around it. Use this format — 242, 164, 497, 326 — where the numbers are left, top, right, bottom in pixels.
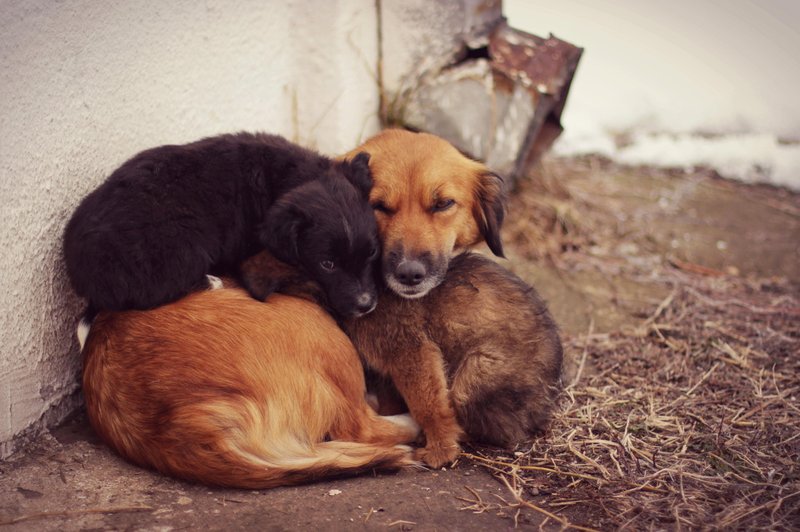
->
0, 416, 524, 531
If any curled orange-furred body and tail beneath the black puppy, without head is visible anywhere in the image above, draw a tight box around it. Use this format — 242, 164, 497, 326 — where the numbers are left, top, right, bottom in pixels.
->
83, 288, 418, 488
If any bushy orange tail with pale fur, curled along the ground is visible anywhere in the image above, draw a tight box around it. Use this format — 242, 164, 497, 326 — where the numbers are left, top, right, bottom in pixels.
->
125, 398, 417, 489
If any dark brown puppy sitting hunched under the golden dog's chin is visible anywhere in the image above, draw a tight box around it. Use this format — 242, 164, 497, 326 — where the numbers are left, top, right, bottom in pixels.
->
242, 252, 562, 467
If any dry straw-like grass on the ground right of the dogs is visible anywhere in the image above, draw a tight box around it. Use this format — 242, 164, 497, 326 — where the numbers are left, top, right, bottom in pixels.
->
465, 157, 800, 530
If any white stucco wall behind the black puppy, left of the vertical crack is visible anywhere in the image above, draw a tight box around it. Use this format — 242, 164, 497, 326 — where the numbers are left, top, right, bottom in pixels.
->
0, 0, 379, 457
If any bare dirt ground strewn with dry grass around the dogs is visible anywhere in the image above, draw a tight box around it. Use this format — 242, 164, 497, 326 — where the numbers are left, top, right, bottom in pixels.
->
0, 158, 800, 530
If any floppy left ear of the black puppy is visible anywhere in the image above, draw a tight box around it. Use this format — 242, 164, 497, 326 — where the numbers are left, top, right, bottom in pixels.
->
258, 201, 311, 265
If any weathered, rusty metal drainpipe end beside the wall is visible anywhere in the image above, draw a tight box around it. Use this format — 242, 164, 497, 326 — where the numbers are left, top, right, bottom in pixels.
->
401, 18, 582, 182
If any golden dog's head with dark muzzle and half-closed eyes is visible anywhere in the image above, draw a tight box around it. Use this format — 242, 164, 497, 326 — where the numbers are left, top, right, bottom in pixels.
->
348, 129, 505, 298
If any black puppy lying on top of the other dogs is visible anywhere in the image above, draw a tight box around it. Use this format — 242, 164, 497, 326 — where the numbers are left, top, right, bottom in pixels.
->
64, 133, 378, 318
